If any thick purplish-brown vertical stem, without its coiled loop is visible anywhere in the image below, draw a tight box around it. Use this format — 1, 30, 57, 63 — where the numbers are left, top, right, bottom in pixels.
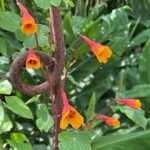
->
50, 6, 64, 150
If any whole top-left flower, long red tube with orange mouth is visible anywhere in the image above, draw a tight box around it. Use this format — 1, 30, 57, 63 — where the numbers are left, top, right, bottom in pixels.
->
16, 0, 37, 35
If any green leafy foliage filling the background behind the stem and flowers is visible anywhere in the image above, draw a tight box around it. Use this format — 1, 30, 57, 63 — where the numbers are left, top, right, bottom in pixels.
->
0, 0, 150, 150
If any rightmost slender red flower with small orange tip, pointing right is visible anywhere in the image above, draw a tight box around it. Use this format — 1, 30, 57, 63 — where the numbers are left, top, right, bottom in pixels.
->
115, 98, 142, 109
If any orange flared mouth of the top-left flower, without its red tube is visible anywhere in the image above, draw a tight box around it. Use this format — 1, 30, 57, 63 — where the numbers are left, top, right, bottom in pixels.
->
21, 18, 37, 35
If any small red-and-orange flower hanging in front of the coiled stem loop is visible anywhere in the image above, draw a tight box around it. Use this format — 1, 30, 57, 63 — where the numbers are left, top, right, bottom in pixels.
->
26, 48, 41, 69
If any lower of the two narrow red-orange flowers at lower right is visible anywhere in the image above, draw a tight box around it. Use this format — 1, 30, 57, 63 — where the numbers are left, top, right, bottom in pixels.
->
97, 115, 120, 128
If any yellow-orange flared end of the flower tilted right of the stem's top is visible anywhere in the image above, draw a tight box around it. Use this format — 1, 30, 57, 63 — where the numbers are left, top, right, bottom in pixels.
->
92, 45, 112, 63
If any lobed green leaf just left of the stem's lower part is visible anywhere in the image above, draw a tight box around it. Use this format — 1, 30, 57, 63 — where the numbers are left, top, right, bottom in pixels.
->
36, 104, 54, 132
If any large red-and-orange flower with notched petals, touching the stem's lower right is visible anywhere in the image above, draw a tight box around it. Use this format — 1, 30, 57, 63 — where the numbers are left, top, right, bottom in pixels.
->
60, 91, 84, 129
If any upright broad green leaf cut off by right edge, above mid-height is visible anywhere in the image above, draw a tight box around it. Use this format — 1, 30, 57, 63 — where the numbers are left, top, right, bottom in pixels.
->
139, 40, 150, 84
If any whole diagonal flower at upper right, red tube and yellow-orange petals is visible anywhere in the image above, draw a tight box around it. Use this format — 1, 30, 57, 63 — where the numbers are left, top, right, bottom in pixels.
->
80, 35, 112, 63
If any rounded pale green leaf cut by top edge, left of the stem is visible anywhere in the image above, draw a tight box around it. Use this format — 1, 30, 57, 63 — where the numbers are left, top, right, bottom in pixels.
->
34, 0, 51, 10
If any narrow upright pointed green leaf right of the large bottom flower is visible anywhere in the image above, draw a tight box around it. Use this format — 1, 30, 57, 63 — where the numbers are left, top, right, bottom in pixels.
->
86, 93, 96, 120
